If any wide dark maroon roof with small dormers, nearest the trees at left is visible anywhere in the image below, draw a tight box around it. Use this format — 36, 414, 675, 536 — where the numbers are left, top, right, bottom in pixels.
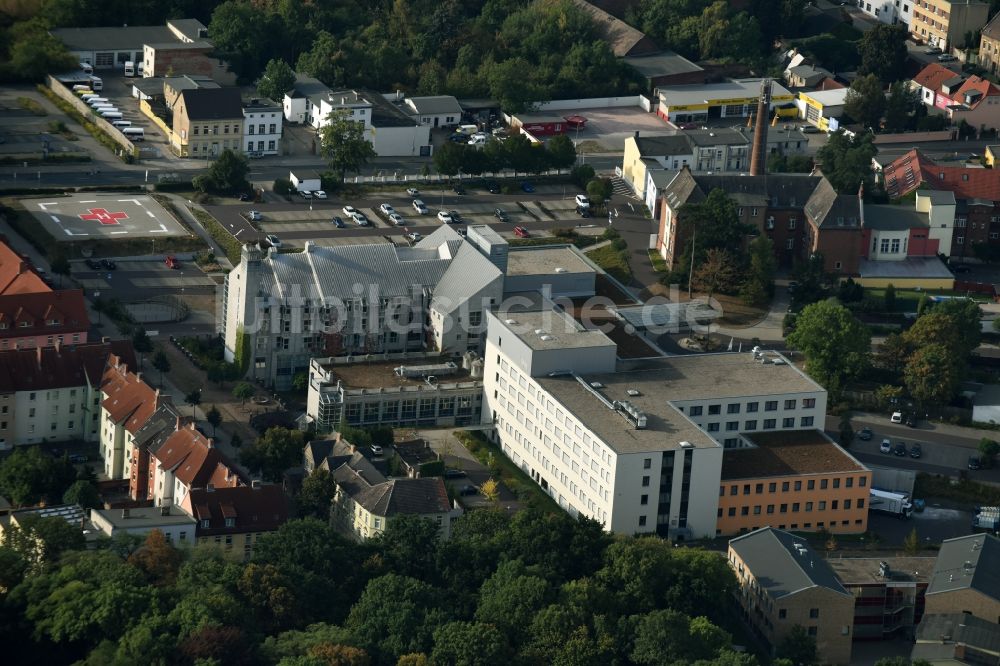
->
181, 485, 288, 536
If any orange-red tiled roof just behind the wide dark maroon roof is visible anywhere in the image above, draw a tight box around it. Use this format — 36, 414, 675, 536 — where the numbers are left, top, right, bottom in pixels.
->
152, 423, 241, 488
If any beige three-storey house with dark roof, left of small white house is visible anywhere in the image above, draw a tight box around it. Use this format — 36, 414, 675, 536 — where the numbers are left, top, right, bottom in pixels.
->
170, 87, 243, 159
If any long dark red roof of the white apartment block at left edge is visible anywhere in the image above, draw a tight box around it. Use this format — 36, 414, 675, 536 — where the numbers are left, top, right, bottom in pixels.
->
0, 340, 134, 392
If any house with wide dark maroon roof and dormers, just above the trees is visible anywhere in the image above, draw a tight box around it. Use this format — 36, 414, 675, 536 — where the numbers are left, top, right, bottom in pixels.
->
180, 481, 289, 560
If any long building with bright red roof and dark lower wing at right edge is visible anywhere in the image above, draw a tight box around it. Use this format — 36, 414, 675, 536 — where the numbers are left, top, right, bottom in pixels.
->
881, 148, 1000, 257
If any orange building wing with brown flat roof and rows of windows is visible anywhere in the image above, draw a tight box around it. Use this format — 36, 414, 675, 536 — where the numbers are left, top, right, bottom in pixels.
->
716, 430, 871, 536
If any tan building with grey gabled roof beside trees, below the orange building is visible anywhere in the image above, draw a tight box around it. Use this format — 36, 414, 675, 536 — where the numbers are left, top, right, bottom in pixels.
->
728, 527, 854, 665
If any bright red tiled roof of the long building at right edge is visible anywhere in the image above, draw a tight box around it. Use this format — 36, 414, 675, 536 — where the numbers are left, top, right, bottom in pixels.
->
883, 148, 1000, 201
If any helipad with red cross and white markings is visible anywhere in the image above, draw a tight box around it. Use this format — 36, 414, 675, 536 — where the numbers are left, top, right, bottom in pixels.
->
21, 193, 188, 242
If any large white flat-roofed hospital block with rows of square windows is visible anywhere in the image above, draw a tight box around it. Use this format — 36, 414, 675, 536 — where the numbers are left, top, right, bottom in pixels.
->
483, 310, 826, 540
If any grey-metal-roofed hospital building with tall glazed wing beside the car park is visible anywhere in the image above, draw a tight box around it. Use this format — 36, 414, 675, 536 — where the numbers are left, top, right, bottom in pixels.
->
228, 226, 505, 389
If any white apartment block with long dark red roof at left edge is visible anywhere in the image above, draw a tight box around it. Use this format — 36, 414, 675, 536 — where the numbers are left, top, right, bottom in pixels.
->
0, 340, 134, 449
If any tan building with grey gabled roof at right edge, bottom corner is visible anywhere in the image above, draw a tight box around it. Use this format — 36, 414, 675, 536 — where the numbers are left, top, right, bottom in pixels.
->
927, 534, 1000, 623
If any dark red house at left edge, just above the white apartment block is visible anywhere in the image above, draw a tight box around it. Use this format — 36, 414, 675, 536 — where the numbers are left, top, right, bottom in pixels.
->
0, 289, 90, 350
